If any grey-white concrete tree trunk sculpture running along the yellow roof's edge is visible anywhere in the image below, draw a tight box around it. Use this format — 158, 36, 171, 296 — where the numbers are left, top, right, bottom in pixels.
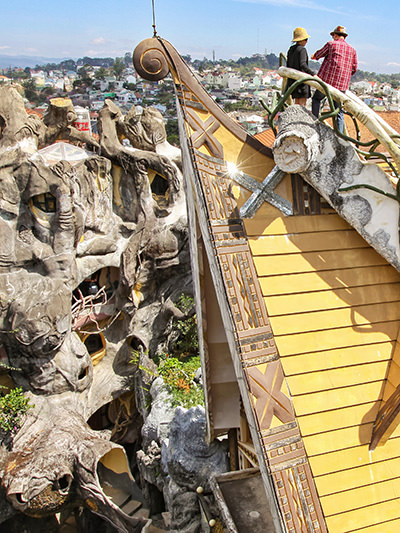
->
273, 105, 400, 270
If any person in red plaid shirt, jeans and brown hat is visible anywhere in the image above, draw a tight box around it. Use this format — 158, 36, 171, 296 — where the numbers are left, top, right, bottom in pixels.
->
311, 26, 357, 132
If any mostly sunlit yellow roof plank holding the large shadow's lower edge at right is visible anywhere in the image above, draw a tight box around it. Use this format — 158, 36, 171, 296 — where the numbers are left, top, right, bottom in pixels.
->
275, 321, 399, 357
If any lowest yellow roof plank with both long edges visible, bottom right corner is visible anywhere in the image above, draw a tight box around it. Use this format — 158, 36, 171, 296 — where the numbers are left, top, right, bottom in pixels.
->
326, 498, 400, 533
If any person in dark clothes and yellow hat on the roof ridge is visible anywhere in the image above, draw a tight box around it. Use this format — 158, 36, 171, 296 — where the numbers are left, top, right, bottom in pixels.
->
286, 28, 314, 106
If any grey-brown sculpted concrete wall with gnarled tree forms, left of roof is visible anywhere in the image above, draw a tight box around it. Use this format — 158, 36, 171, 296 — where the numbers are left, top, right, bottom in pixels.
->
0, 87, 195, 531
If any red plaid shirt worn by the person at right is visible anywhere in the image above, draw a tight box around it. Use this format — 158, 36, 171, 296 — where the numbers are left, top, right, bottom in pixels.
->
314, 39, 357, 91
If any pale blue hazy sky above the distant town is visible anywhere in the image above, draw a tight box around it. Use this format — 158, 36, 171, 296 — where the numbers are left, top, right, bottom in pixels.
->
0, 0, 400, 73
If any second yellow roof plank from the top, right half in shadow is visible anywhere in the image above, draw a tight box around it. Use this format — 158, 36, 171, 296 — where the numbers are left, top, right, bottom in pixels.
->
249, 229, 370, 255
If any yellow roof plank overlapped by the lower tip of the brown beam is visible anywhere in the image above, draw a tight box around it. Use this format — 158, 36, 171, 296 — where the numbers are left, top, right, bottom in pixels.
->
310, 437, 400, 477
